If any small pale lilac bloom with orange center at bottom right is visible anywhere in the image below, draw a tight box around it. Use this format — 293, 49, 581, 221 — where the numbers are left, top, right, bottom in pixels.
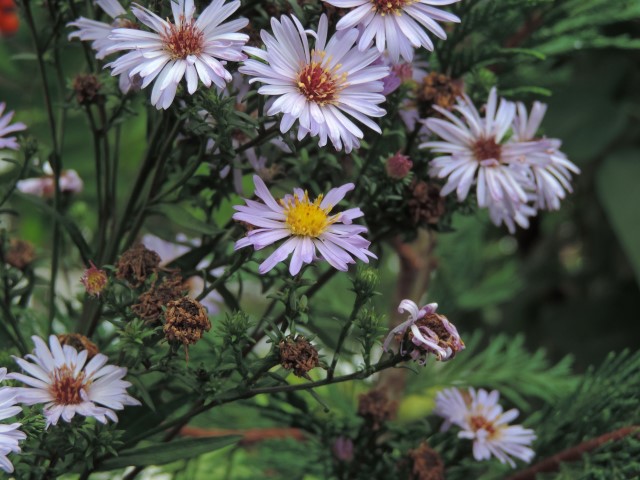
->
434, 388, 536, 468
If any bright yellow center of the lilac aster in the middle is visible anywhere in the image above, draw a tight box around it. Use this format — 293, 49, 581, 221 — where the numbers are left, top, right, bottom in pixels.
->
280, 192, 340, 238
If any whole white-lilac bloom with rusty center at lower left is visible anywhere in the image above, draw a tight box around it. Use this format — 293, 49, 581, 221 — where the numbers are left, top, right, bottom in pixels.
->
7, 335, 140, 427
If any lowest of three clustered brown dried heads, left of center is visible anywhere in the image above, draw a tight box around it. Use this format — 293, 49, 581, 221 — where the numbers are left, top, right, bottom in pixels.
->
163, 297, 211, 360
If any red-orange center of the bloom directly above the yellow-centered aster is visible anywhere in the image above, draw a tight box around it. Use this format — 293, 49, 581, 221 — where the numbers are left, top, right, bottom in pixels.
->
297, 57, 346, 106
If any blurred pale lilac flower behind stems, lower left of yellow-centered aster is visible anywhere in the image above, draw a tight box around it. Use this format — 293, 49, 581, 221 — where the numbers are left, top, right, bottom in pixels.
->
142, 233, 224, 315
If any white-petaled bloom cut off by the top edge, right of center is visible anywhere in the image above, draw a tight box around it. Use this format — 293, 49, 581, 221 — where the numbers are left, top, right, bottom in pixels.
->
325, 0, 460, 63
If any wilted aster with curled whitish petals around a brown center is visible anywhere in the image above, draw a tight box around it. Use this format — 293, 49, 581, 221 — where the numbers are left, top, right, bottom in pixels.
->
383, 299, 464, 365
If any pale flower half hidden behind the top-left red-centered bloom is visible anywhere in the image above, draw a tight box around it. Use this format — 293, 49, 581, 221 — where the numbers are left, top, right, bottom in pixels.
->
67, 0, 137, 93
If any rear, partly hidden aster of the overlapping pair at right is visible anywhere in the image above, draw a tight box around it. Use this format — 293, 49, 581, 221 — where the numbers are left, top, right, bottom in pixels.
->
513, 102, 580, 210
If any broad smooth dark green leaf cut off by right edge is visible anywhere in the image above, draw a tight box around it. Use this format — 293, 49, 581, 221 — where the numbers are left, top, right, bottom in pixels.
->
596, 149, 640, 284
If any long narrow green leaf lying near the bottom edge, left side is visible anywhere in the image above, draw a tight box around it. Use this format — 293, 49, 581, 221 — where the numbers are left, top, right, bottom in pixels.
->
97, 435, 242, 471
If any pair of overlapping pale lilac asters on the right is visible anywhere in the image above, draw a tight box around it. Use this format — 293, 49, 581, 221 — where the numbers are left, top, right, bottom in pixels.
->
421, 88, 580, 232
